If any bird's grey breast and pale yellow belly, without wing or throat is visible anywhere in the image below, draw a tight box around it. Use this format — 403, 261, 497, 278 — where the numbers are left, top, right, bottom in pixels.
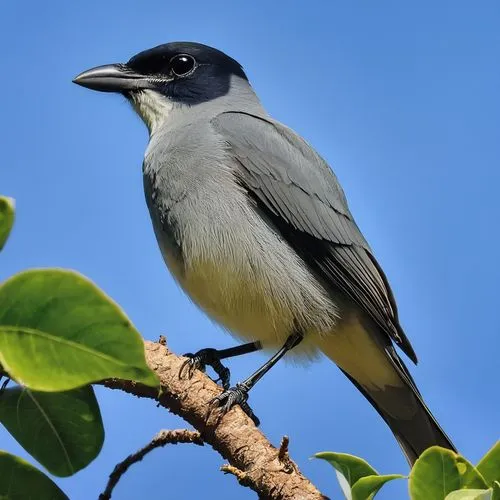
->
144, 132, 331, 345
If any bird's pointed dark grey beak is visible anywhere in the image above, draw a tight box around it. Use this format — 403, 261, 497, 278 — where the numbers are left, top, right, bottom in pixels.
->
73, 64, 153, 92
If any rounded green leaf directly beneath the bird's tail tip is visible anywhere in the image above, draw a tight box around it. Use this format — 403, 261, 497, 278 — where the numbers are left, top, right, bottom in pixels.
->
409, 446, 487, 500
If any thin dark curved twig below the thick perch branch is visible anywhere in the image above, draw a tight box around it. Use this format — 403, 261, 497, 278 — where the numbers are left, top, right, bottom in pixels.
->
99, 429, 203, 500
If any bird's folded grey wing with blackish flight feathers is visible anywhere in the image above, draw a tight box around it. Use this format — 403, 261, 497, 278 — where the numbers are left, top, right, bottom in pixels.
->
212, 112, 417, 363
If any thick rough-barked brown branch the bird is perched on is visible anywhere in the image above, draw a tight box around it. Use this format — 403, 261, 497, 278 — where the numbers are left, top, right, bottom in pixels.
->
103, 339, 326, 500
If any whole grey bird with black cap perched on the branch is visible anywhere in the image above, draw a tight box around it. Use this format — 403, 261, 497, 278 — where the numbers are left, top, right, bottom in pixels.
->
73, 42, 456, 465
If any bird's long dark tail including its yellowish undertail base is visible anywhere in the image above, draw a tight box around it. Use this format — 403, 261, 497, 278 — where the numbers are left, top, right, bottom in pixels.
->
320, 316, 456, 465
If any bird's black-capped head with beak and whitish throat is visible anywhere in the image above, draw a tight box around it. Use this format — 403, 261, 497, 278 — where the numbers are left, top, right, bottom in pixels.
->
73, 42, 251, 131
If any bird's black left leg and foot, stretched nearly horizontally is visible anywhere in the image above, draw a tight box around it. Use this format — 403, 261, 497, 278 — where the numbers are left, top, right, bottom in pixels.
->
179, 342, 262, 389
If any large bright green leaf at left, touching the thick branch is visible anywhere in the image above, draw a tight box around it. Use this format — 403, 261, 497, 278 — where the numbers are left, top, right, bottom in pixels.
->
0, 269, 158, 391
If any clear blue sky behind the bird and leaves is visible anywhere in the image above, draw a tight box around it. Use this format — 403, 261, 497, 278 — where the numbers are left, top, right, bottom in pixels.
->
0, 0, 500, 500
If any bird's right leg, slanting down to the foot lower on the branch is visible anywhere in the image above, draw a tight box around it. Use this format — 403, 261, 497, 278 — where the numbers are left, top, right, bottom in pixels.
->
210, 332, 304, 425
